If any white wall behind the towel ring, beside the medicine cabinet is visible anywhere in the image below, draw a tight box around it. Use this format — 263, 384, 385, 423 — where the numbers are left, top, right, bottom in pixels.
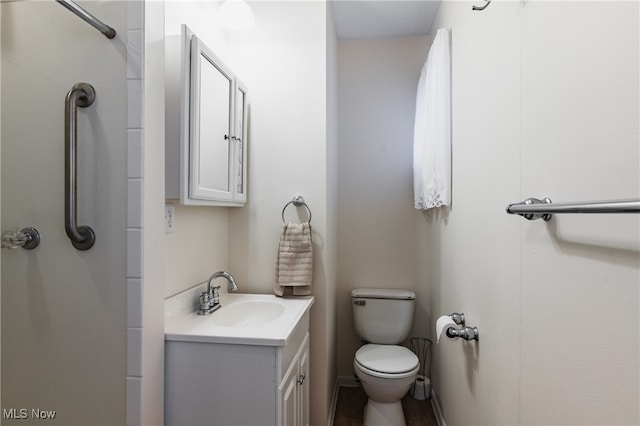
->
228, 1, 335, 424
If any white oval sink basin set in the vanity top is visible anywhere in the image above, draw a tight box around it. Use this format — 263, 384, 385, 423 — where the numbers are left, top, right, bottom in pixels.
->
211, 301, 284, 327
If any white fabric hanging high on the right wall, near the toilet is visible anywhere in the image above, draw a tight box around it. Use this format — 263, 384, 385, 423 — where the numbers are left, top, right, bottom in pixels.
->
413, 28, 451, 210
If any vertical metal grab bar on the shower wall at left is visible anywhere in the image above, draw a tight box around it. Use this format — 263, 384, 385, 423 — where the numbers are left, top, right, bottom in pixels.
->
64, 83, 96, 250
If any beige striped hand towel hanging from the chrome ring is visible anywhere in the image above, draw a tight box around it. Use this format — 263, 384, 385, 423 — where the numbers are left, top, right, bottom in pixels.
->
273, 222, 313, 296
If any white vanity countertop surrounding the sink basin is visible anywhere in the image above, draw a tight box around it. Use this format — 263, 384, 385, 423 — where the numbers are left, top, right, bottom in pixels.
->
165, 286, 314, 346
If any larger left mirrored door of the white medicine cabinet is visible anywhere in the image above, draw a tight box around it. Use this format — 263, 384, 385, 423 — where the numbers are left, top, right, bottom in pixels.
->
189, 36, 234, 201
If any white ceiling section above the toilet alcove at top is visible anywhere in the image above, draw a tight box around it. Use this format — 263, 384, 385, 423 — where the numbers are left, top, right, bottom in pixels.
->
331, 0, 440, 39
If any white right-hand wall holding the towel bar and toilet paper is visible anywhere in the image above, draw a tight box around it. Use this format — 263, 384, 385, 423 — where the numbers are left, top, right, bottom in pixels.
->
432, 1, 640, 425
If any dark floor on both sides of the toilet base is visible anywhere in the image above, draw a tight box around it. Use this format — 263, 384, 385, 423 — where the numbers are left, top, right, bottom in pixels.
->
333, 386, 438, 426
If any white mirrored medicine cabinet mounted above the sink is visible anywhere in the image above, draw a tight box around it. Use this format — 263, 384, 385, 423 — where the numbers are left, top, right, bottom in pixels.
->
165, 25, 248, 206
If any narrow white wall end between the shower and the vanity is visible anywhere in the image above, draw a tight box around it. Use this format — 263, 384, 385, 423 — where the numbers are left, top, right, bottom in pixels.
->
139, 1, 165, 426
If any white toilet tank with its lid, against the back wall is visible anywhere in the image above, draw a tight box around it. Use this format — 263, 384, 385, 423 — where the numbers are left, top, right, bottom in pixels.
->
351, 288, 416, 345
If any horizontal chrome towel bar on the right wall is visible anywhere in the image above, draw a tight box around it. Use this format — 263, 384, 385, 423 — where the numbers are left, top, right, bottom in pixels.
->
507, 198, 640, 221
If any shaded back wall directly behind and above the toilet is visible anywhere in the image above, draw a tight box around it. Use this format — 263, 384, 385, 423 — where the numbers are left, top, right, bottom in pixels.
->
337, 36, 431, 376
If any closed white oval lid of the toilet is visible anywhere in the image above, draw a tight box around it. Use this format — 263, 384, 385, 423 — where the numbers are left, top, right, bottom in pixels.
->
356, 343, 419, 374
